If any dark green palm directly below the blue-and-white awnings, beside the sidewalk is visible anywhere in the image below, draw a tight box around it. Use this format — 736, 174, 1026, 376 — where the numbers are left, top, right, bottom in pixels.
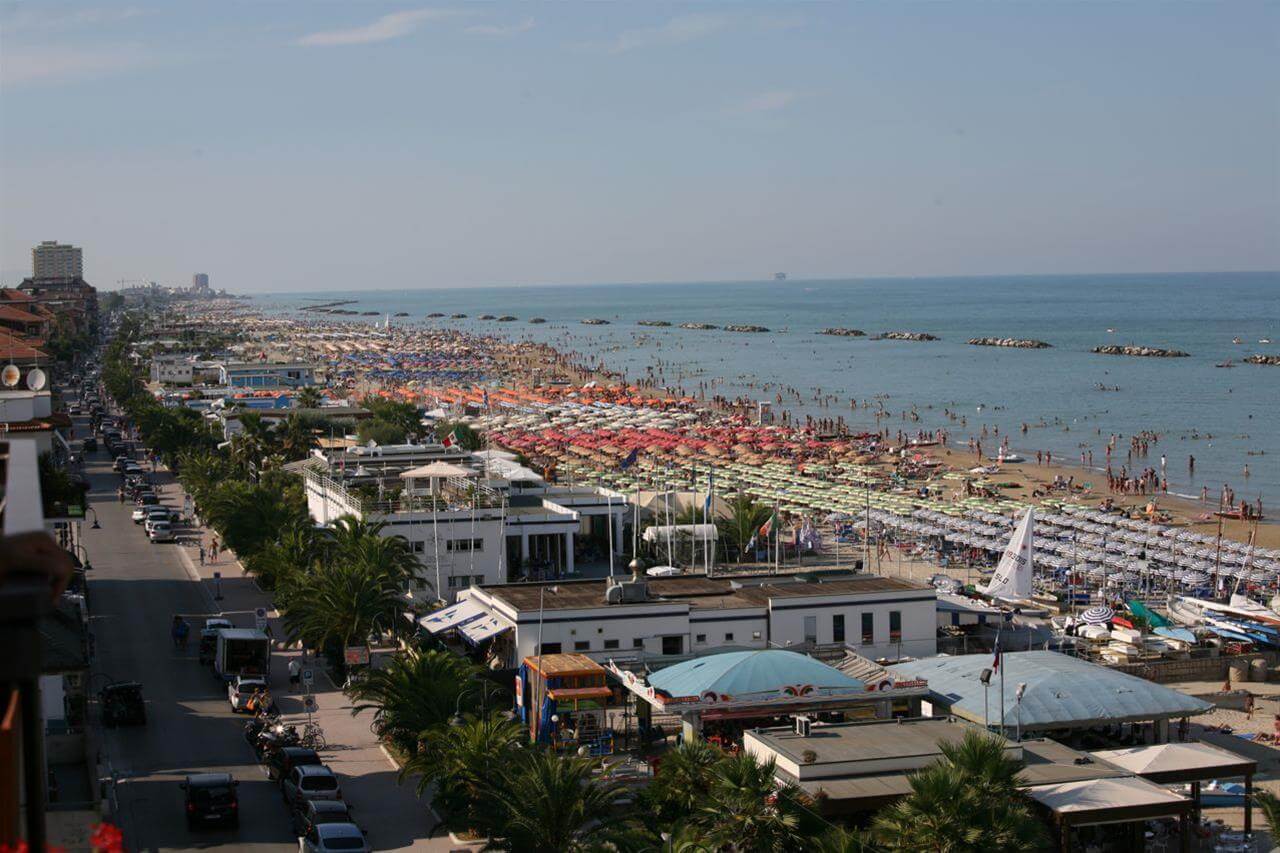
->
349, 649, 480, 756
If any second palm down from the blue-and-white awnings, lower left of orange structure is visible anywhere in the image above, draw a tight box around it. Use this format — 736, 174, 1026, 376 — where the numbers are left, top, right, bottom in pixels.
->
399, 712, 519, 835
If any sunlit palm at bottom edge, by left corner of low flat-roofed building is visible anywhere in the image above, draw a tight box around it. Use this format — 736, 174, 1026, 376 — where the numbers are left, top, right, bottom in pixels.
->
694, 753, 818, 852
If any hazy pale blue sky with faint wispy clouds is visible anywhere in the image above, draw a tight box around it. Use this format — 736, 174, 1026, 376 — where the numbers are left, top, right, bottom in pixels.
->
0, 0, 1280, 293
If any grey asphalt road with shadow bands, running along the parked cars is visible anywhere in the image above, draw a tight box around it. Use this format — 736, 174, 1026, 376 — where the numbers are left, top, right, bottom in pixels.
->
77, 432, 297, 850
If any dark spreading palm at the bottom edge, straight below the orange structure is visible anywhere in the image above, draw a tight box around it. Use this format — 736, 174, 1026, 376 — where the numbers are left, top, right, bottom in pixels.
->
490, 749, 630, 853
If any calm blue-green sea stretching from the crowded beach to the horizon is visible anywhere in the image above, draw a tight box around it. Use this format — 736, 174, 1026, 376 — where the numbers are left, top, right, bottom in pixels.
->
255, 273, 1280, 502
